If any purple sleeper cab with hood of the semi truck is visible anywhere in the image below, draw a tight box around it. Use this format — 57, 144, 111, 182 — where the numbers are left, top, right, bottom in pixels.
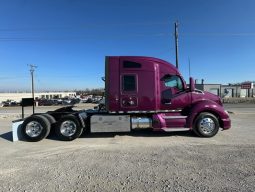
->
105, 56, 230, 136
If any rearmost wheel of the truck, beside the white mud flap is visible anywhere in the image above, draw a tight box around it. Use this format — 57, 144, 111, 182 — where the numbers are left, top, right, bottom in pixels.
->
21, 115, 50, 142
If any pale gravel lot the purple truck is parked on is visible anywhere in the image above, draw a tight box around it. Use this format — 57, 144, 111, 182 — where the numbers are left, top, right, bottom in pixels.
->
0, 105, 255, 192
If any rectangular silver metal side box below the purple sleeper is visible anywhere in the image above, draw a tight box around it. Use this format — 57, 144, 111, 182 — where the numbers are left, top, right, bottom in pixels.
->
90, 115, 131, 133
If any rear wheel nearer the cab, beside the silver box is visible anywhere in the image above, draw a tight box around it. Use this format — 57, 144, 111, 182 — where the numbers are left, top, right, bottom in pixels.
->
55, 115, 83, 141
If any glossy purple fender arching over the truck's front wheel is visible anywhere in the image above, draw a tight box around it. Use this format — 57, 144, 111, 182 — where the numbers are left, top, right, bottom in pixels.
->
186, 100, 229, 129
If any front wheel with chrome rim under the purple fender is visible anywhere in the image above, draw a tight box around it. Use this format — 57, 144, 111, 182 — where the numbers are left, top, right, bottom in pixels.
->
193, 113, 220, 137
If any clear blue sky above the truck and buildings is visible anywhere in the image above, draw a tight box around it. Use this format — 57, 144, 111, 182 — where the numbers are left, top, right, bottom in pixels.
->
0, 0, 255, 91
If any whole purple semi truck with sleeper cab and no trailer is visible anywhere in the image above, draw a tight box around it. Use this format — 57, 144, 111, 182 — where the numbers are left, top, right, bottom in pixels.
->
20, 56, 231, 141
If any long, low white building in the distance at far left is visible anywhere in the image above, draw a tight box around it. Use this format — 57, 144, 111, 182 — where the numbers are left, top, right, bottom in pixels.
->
0, 92, 76, 102
